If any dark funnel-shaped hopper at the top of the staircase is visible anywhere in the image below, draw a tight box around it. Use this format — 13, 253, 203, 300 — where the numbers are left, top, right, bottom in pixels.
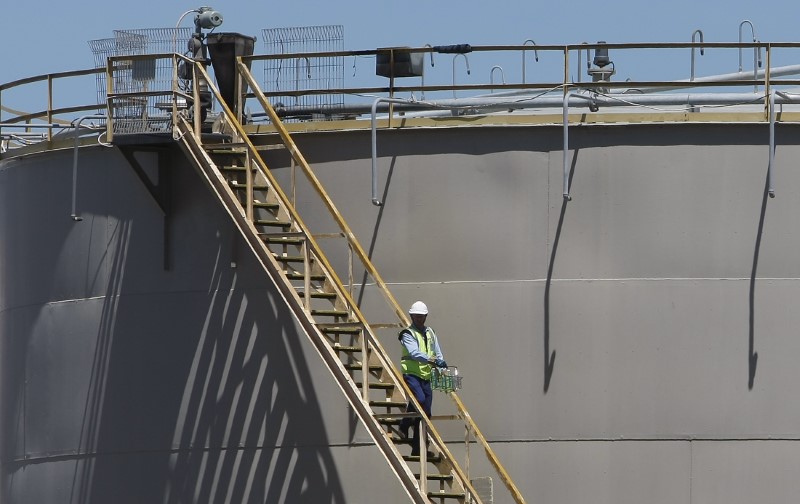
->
206, 33, 256, 115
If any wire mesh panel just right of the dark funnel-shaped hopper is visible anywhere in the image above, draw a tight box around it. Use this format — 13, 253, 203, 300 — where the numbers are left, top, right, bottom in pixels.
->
261, 25, 345, 122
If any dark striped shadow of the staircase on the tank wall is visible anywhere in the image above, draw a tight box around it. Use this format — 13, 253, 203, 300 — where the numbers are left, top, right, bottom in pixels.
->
77, 157, 349, 504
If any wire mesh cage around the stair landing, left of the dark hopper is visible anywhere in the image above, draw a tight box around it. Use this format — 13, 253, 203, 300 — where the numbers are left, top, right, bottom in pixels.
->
89, 27, 192, 133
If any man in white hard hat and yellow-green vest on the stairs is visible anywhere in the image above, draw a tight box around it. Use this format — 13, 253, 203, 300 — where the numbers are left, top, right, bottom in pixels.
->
398, 301, 447, 456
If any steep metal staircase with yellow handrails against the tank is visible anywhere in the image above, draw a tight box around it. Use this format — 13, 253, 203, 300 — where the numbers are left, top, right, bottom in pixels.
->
165, 57, 524, 504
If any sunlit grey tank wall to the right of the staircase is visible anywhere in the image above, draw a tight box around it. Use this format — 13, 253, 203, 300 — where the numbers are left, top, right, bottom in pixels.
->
260, 124, 800, 504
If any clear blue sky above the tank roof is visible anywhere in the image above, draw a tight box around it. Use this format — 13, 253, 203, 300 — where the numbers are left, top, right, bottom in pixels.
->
0, 0, 800, 112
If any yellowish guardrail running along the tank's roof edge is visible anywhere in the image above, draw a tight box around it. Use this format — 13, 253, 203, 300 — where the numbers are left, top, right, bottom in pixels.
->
6, 41, 800, 151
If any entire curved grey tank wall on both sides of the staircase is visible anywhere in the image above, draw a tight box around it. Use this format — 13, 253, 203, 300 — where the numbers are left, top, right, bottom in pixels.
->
0, 124, 800, 504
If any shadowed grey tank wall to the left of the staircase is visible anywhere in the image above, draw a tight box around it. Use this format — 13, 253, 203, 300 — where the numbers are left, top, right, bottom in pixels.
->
0, 146, 405, 504
